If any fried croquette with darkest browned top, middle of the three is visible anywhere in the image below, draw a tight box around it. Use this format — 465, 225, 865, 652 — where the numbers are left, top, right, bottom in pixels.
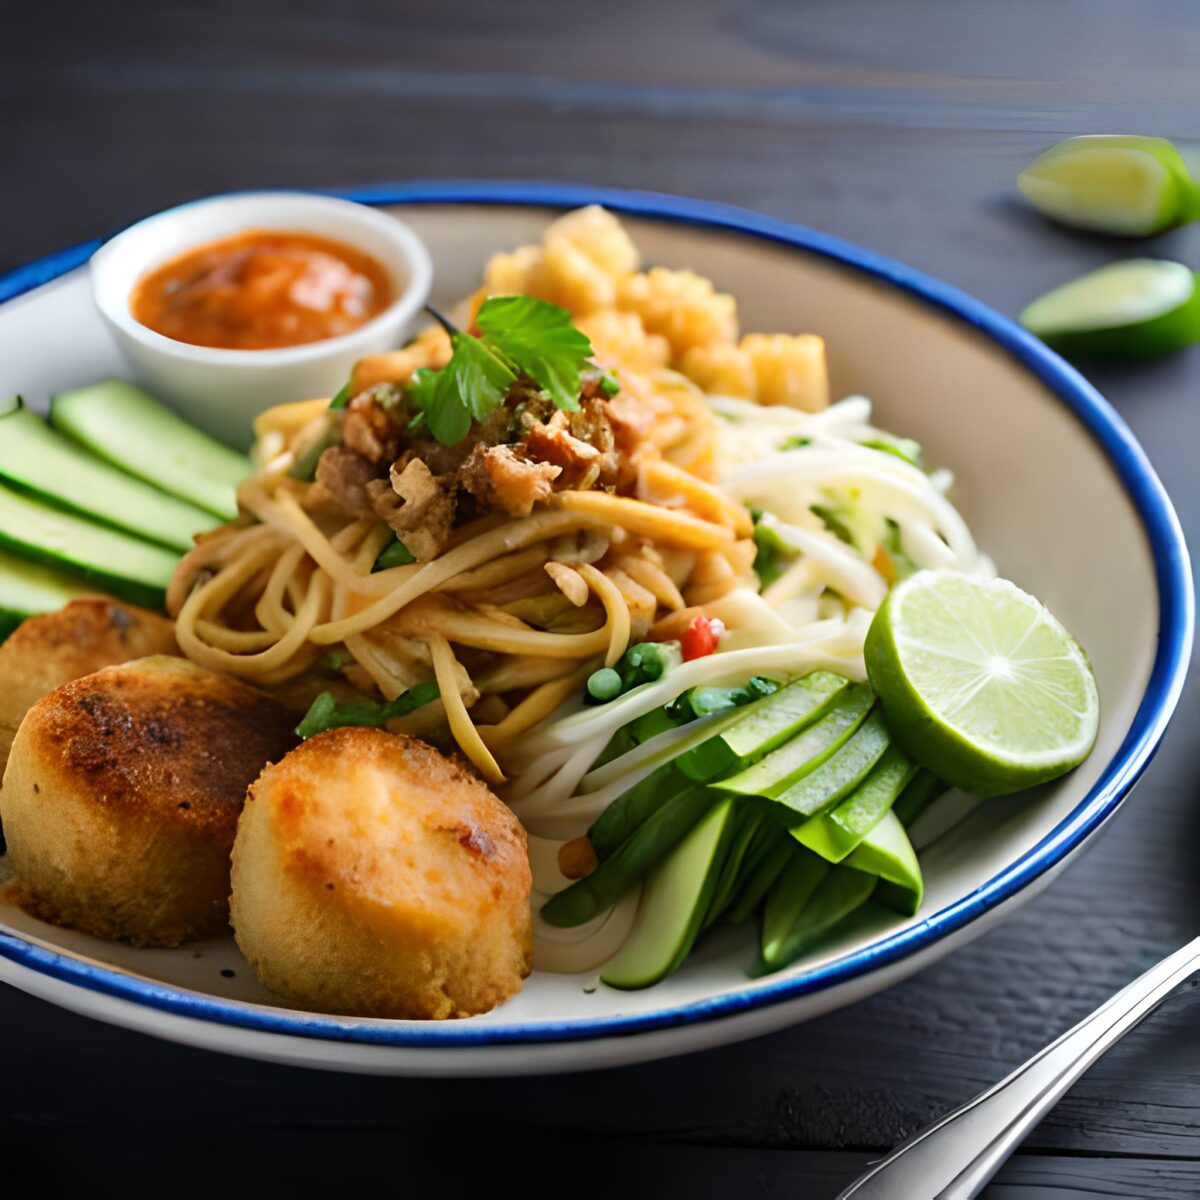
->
0, 656, 296, 946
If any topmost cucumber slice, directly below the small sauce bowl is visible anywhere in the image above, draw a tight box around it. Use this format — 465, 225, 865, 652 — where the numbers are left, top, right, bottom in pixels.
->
50, 379, 251, 521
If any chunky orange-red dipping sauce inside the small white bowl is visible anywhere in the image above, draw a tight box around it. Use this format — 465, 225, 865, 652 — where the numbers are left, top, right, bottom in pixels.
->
130, 229, 392, 350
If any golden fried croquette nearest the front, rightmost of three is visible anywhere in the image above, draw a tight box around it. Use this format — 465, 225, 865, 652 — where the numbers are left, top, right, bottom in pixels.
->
230, 728, 532, 1019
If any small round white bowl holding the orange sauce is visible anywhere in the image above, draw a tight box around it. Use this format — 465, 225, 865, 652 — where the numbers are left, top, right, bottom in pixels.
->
90, 192, 433, 446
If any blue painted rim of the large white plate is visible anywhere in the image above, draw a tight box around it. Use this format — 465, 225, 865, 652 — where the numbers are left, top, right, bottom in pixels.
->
0, 180, 1194, 1049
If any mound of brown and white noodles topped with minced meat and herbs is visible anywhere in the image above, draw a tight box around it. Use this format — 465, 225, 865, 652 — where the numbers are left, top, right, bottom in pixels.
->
154, 208, 1027, 993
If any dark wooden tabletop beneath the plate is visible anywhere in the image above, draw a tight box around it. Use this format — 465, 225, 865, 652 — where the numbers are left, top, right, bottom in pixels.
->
0, 0, 1200, 1200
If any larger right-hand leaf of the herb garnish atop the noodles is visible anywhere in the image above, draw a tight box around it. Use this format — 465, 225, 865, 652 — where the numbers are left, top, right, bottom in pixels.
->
475, 296, 592, 413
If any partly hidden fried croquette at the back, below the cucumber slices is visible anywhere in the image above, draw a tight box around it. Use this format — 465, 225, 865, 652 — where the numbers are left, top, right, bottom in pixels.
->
0, 596, 179, 774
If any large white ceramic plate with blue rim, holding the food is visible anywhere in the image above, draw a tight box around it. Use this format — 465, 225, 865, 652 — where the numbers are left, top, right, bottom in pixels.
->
0, 184, 1193, 1075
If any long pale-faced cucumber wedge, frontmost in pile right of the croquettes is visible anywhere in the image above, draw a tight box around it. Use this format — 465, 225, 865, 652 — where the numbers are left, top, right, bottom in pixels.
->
600, 799, 733, 989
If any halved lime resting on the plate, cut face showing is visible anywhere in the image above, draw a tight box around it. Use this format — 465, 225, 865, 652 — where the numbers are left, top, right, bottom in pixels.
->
865, 571, 1099, 796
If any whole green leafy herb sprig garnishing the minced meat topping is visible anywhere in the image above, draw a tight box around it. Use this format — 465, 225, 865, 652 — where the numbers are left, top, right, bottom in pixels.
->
409, 296, 592, 445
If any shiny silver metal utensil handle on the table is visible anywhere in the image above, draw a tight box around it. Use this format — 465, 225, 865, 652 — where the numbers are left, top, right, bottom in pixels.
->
838, 938, 1200, 1200
